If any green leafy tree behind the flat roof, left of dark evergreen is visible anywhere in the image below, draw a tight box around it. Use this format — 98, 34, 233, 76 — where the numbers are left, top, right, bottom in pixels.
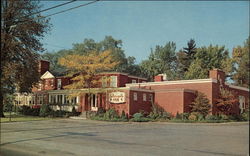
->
140, 42, 176, 80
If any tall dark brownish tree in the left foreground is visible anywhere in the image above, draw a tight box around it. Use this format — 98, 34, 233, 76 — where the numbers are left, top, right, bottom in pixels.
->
0, 0, 50, 117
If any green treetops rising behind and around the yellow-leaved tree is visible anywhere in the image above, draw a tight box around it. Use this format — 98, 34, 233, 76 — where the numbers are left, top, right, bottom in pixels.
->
42, 36, 141, 76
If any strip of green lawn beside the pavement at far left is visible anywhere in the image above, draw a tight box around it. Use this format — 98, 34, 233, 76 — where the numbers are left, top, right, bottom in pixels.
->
0, 112, 52, 123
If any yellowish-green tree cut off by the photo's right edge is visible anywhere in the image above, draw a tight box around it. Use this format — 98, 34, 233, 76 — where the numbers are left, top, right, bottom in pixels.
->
232, 37, 250, 88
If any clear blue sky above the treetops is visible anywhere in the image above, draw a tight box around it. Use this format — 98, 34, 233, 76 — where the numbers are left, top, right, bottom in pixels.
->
41, 1, 249, 63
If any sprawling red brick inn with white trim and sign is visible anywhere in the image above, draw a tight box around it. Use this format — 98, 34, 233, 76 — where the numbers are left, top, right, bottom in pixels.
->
17, 61, 249, 116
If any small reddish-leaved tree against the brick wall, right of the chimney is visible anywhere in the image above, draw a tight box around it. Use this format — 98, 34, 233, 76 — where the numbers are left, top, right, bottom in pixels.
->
215, 89, 238, 114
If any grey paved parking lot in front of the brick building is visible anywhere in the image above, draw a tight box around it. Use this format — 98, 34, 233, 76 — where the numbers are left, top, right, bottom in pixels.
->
0, 119, 249, 156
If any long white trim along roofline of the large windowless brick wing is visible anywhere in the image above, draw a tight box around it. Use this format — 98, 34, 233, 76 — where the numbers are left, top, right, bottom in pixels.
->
126, 78, 217, 87
